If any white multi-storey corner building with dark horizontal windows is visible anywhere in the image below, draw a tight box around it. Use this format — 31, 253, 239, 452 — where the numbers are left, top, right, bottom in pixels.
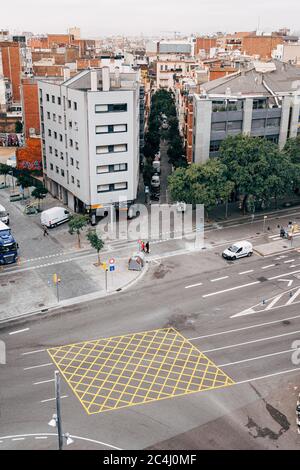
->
38, 67, 140, 215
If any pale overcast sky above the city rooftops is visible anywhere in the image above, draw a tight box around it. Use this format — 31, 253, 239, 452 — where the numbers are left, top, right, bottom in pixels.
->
0, 0, 300, 37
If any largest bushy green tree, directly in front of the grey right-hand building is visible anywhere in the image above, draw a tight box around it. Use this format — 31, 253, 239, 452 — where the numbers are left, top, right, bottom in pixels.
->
219, 135, 296, 213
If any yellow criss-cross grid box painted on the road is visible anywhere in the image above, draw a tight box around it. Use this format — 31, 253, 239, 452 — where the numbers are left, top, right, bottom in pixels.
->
48, 328, 234, 414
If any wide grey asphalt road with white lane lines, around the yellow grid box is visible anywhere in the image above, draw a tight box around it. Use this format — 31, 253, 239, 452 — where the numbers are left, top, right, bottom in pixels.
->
0, 246, 300, 449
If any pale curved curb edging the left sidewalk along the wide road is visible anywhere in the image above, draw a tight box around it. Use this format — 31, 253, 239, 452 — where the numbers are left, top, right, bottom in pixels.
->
0, 262, 150, 328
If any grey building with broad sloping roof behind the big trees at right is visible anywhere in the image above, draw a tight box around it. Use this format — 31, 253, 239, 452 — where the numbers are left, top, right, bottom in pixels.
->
193, 61, 300, 163
